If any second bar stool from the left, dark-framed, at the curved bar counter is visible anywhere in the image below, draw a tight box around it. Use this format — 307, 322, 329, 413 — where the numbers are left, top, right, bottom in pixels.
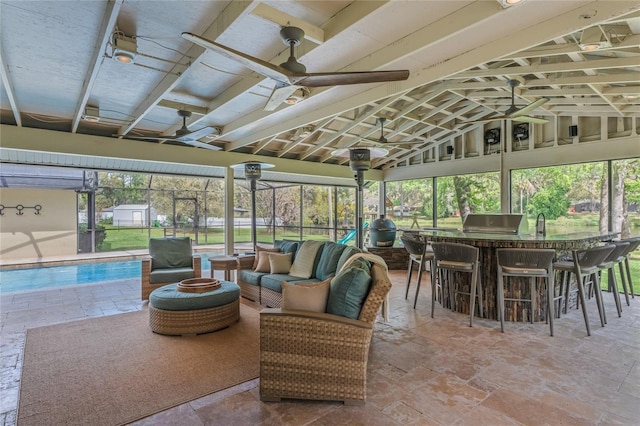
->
431, 243, 484, 327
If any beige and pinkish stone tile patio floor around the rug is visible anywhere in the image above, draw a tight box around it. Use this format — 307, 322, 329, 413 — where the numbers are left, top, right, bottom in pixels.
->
0, 271, 640, 425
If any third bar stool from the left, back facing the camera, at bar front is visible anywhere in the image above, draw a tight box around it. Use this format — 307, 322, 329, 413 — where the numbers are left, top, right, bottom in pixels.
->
496, 248, 556, 336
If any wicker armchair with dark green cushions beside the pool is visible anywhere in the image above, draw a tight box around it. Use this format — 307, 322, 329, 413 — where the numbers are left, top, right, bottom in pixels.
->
142, 237, 201, 300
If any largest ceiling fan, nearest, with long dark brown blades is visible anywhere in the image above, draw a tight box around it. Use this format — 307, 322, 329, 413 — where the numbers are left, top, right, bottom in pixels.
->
182, 27, 409, 111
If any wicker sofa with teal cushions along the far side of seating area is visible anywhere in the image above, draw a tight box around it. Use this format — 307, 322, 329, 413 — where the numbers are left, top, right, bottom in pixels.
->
237, 241, 362, 308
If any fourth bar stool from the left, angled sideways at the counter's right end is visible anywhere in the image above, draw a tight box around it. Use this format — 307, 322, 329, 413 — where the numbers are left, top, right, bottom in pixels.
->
553, 244, 616, 336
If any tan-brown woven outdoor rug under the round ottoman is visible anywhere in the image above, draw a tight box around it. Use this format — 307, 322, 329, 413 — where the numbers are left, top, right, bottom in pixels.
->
18, 303, 260, 425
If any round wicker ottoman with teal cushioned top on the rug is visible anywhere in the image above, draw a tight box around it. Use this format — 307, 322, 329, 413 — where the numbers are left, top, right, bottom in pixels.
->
149, 281, 240, 336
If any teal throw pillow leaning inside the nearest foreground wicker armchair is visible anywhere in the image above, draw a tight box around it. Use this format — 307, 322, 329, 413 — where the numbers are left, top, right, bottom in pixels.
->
327, 259, 371, 319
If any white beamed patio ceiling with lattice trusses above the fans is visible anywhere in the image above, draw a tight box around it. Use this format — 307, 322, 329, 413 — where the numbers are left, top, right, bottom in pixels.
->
0, 0, 640, 180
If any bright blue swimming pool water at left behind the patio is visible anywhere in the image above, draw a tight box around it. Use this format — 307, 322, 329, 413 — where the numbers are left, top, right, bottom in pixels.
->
0, 257, 211, 293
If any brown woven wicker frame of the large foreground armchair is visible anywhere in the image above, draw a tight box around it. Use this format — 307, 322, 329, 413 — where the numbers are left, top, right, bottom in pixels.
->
260, 264, 391, 405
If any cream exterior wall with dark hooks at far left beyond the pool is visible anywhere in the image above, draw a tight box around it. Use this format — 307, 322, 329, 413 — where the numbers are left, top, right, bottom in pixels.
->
0, 188, 78, 262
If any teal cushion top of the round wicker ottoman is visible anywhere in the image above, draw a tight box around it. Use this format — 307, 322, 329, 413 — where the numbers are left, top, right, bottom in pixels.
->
149, 281, 240, 311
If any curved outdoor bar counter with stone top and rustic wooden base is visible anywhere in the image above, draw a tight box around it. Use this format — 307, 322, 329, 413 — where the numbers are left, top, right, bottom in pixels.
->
420, 229, 618, 321
